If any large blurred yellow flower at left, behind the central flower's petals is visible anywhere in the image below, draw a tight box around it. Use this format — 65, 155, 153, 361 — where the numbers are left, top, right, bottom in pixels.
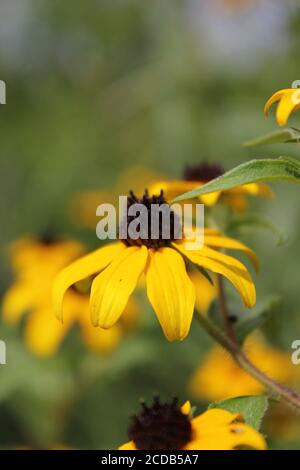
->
3, 237, 137, 357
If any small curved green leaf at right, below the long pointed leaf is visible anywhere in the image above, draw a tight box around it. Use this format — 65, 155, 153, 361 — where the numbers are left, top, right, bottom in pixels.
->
225, 214, 286, 246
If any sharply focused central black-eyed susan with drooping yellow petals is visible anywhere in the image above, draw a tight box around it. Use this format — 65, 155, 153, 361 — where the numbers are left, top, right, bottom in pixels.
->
53, 192, 257, 340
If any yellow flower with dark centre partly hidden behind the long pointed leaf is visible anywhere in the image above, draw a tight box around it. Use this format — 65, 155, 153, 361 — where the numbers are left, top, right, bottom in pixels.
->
151, 162, 273, 212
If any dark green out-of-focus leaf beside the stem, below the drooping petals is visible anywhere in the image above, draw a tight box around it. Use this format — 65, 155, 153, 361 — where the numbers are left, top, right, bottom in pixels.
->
235, 295, 281, 343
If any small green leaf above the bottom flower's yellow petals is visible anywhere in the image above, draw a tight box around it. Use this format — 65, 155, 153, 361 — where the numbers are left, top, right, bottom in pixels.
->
208, 395, 268, 431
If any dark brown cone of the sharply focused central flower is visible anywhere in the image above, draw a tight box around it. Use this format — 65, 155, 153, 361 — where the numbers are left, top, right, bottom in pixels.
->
122, 190, 182, 249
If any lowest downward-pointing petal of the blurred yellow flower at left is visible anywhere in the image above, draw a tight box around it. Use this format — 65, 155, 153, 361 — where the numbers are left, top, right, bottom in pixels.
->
25, 308, 72, 357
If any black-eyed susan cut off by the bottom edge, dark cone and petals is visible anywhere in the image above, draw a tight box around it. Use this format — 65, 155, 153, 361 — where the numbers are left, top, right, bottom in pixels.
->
119, 398, 266, 450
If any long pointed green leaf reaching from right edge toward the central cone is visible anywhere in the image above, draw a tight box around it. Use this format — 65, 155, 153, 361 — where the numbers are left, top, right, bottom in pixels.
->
173, 157, 300, 202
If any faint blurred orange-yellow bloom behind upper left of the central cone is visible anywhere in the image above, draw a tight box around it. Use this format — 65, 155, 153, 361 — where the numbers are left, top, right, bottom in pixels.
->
70, 166, 161, 229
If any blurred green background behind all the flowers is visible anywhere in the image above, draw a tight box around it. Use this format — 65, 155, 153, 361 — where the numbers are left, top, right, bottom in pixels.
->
0, 0, 300, 449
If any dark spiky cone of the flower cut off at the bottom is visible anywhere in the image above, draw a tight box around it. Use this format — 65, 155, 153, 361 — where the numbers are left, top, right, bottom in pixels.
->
129, 398, 192, 450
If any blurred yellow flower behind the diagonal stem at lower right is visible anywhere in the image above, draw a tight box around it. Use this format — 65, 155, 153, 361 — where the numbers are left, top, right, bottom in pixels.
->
189, 336, 296, 401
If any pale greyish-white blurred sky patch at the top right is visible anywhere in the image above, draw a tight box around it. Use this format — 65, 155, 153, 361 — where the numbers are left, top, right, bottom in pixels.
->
187, 0, 299, 70
